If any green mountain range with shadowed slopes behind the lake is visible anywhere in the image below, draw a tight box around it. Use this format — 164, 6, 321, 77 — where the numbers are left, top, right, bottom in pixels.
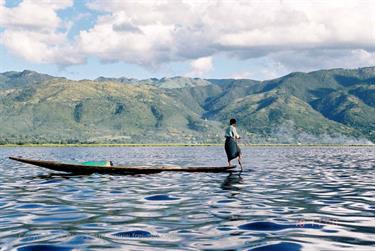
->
0, 67, 375, 143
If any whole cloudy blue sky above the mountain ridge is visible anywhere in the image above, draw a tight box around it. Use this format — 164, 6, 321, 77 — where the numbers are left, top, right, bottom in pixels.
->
0, 0, 375, 80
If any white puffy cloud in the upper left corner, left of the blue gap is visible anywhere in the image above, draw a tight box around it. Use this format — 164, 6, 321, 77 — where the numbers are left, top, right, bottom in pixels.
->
0, 0, 85, 65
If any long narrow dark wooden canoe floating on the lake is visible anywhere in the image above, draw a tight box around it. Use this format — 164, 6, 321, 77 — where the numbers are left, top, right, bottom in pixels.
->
9, 157, 236, 174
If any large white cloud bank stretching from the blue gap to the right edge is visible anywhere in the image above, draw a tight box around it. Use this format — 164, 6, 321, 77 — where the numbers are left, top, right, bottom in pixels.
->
82, 0, 375, 68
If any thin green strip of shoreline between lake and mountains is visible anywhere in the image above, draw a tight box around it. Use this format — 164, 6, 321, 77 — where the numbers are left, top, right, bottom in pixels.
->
0, 143, 375, 147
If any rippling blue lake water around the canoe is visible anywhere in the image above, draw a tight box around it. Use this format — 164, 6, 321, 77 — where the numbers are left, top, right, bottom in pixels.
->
0, 147, 375, 251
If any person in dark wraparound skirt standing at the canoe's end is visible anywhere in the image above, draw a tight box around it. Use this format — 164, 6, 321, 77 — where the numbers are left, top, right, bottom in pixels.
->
225, 119, 242, 169
